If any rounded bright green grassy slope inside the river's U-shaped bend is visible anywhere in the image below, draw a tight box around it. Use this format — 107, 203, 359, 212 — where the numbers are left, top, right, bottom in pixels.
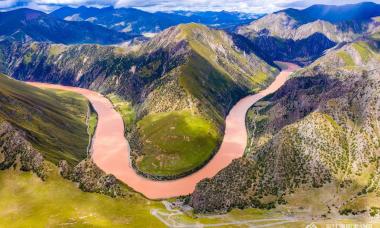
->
137, 111, 220, 176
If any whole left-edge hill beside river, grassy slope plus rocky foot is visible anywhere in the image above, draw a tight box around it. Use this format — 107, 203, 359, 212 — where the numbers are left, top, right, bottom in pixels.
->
0, 75, 88, 172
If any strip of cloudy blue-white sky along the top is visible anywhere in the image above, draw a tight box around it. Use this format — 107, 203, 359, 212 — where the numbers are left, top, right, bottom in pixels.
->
0, 0, 380, 13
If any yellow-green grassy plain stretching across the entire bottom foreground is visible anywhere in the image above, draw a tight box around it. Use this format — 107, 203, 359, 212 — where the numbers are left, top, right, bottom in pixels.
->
0, 167, 376, 228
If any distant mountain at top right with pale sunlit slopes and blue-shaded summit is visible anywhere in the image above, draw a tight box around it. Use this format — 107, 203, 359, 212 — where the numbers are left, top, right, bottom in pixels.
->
238, 3, 380, 42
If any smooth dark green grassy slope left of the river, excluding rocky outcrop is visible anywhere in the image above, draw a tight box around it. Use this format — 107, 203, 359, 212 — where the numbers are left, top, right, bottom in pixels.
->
0, 75, 88, 164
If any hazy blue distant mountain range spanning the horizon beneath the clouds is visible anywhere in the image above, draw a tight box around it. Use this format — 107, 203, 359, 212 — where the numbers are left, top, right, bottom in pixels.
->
0, 2, 380, 48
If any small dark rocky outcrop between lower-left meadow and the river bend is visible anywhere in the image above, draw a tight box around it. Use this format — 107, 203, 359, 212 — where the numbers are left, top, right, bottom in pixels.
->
58, 159, 124, 197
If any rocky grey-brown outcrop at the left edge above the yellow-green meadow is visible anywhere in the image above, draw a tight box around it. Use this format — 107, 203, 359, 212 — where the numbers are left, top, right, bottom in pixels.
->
0, 119, 46, 179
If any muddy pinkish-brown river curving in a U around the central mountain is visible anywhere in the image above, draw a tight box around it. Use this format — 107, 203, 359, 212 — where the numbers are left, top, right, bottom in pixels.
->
29, 63, 298, 199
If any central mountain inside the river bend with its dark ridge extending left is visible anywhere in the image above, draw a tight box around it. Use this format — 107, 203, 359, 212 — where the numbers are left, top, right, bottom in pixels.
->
1, 24, 277, 178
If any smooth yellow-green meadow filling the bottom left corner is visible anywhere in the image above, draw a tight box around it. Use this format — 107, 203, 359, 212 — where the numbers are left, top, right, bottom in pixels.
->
0, 164, 164, 228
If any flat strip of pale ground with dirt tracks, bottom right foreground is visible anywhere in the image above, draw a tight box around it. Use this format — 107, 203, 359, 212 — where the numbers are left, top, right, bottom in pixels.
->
155, 202, 379, 228
